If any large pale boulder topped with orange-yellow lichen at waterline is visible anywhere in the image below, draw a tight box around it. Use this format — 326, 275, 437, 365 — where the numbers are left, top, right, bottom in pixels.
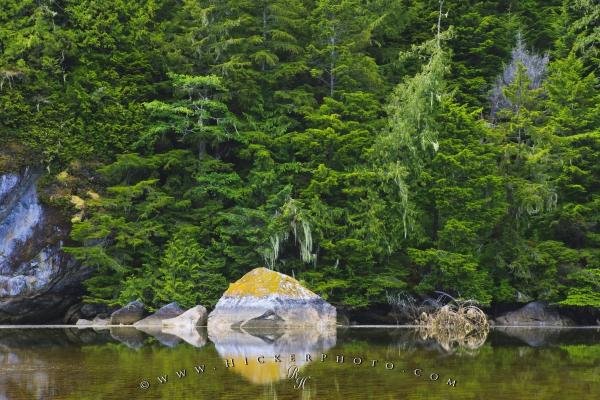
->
208, 268, 336, 335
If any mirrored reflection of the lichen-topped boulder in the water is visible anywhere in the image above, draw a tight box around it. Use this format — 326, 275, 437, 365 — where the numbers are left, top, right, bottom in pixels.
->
208, 326, 336, 384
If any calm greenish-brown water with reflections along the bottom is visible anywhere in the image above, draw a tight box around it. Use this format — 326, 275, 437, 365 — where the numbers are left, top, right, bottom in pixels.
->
0, 328, 600, 400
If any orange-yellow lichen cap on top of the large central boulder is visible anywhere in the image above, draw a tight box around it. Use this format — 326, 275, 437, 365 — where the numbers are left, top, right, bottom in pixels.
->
224, 267, 318, 299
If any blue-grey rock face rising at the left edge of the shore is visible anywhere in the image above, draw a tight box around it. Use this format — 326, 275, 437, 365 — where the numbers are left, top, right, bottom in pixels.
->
0, 169, 91, 323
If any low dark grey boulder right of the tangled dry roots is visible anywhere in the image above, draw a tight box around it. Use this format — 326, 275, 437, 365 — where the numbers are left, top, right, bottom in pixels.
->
495, 301, 573, 326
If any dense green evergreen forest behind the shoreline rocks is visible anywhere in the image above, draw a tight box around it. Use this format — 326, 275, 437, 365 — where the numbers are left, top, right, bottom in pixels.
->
0, 0, 600, 309
